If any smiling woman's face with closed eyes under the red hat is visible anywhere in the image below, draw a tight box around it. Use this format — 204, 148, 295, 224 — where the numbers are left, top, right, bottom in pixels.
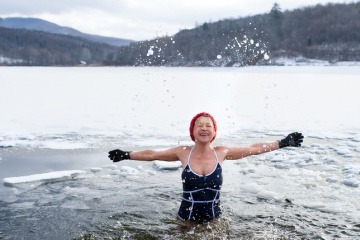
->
193, 116, 215, 142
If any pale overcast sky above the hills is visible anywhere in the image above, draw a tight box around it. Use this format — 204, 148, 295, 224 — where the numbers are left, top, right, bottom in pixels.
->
0, 0, 358, 41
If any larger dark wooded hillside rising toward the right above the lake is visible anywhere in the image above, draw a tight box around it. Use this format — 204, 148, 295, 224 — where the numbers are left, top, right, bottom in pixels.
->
114, 2, 360, 66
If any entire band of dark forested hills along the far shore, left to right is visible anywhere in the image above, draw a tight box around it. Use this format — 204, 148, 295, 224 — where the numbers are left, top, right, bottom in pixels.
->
0, 2, 360, 66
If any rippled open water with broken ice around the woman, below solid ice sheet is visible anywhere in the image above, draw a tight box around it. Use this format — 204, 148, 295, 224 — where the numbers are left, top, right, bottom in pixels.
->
0, 139, 360, 239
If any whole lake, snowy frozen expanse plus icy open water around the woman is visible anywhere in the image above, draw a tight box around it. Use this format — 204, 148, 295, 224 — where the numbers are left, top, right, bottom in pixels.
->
0, 66, 360, 239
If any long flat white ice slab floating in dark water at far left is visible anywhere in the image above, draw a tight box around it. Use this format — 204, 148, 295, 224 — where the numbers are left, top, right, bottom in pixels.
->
3, 170, 86, 187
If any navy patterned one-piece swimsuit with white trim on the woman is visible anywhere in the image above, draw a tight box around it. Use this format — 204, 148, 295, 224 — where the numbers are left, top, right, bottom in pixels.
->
178, 147, 223, 222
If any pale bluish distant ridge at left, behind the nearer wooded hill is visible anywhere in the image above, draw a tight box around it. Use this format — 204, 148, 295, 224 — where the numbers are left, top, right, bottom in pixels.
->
0, 17, 134, 47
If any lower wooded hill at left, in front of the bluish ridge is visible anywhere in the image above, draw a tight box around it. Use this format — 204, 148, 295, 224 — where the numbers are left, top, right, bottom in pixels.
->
0, 27, 118, 66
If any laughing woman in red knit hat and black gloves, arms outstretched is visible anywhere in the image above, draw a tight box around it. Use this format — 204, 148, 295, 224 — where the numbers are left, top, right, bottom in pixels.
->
109, 112, 304, 223
